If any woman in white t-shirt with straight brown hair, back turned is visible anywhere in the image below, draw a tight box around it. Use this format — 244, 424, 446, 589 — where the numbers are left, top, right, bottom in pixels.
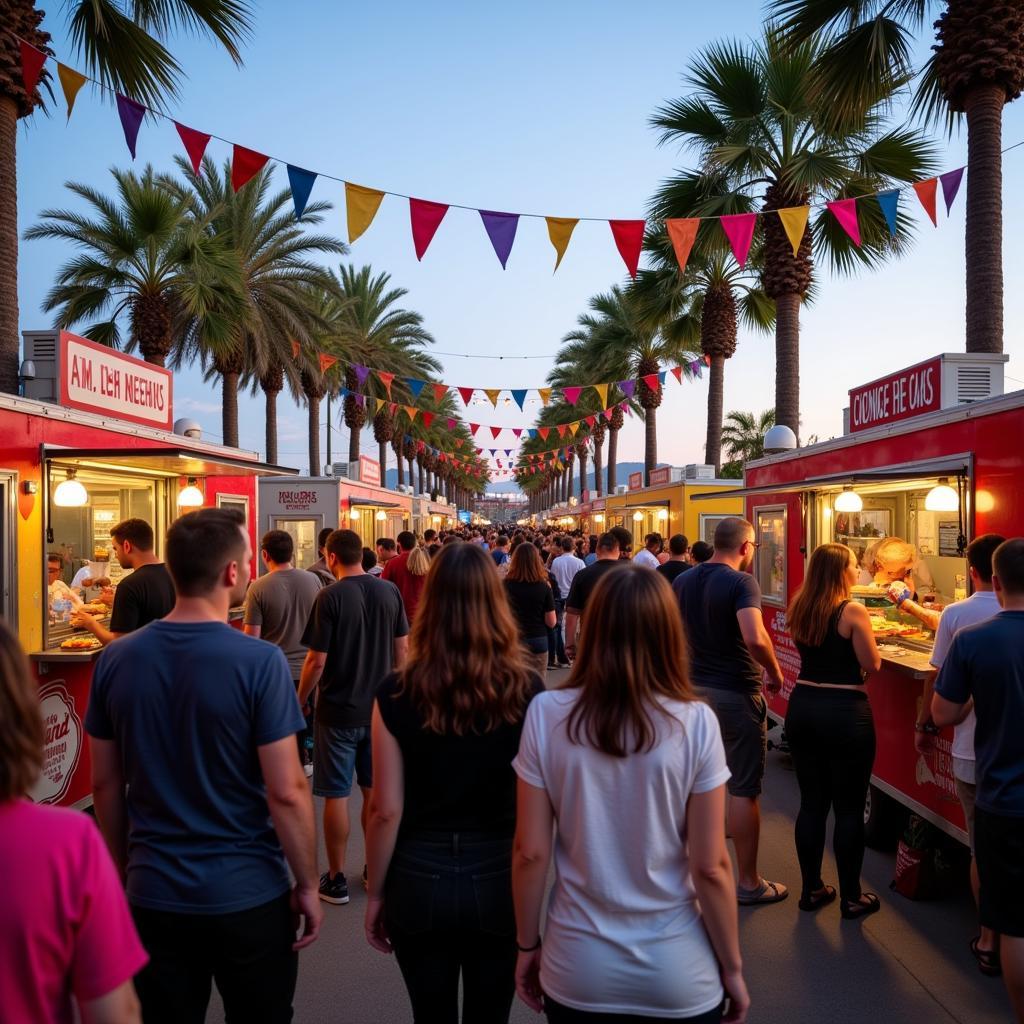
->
512, 566, 750, 1024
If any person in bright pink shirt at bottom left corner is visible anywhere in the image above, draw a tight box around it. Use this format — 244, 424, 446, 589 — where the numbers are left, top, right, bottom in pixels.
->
0, 621, 148, 1024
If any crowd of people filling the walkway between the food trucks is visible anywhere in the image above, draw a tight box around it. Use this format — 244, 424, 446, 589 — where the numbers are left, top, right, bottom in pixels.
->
0, 508, 1024, 1024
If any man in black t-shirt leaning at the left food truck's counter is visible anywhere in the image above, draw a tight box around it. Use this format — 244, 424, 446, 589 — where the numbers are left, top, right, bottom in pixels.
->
72, 519, 174, 646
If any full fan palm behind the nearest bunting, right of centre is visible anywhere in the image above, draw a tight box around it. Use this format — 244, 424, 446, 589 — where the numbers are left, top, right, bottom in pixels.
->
652, 31, 935, 433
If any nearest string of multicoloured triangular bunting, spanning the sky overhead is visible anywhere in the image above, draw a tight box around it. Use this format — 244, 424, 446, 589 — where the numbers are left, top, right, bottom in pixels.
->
19, 40, 965, 278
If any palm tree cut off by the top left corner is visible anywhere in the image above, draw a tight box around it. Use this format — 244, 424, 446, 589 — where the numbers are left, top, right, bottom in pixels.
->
0, 0, 250, 393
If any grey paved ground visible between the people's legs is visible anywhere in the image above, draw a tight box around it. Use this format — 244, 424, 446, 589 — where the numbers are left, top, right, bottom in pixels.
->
208, 673, 1011, 1024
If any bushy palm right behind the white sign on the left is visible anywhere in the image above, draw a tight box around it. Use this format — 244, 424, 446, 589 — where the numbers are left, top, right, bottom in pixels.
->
25, 166, 242, 367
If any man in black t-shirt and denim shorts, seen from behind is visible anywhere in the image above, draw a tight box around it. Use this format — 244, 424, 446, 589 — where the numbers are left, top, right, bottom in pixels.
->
299, 529, 409, 903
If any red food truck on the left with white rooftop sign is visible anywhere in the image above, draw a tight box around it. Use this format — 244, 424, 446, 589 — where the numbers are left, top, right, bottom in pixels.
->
7, 331, 293, 807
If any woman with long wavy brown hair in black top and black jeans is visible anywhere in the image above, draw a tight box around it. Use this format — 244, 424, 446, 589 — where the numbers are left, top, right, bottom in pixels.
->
366, 544, 543, 1024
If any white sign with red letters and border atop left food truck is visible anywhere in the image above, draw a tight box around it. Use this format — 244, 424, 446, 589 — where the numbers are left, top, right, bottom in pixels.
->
60, 331, 173, 430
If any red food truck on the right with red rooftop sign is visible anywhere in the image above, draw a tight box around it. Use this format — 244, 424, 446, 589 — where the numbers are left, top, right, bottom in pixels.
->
696, 353, 1024, 843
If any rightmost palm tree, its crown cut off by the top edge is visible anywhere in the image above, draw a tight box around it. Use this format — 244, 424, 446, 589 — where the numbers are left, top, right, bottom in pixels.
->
769, 0, 1024, 352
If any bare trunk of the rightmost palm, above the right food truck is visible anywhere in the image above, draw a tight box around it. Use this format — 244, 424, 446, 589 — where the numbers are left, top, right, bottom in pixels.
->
964, 85, 1007, 352
